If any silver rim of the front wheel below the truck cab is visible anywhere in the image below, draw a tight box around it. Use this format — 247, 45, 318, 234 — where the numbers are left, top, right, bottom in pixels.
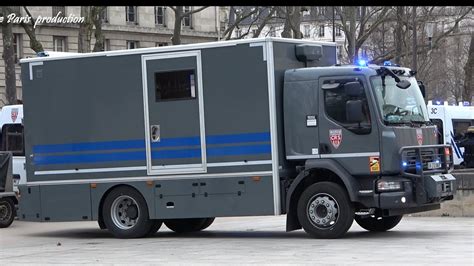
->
306, 193, 339, 229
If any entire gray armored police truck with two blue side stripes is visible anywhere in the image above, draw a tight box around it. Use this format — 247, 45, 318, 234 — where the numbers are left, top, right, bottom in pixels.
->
19, 38, 455, 238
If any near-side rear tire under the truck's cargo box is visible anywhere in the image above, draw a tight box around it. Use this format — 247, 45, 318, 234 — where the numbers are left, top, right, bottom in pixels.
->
102, 186, 154, 238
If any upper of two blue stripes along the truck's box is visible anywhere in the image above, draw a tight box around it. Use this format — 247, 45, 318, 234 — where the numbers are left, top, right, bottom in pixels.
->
33, 132, 270, 154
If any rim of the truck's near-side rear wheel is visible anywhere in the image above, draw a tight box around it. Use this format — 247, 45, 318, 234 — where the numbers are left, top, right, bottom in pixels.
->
110, 195, 140, 230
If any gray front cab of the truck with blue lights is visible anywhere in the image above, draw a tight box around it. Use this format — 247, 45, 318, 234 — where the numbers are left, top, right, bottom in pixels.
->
283, 61, 455, 236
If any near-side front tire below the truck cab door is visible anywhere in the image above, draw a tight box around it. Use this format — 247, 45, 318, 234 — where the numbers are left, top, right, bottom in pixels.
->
297, 182, 354, 238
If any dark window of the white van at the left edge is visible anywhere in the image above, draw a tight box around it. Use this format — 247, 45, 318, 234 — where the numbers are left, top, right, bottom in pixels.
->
2, 124, 25, 156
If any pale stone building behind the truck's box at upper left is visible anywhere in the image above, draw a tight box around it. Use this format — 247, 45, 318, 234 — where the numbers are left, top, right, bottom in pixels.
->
0, 6, 221, 106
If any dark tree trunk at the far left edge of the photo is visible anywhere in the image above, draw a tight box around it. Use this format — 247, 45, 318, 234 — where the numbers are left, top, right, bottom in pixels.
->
1, 6, 17, 104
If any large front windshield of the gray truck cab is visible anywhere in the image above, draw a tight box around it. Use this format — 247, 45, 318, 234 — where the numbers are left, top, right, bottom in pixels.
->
371, 76, 429, 124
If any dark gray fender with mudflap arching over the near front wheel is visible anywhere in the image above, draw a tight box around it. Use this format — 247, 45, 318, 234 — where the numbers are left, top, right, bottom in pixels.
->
286, 159, 359, 231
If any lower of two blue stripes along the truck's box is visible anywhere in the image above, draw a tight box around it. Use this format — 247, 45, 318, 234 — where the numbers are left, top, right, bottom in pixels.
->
33, 144, 271, 165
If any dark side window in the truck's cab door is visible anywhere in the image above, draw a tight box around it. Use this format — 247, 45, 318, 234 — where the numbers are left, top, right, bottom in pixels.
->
323, 79, 371, 134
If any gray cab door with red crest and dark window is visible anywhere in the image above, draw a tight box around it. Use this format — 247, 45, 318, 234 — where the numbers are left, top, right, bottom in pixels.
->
318, 76, 380, 175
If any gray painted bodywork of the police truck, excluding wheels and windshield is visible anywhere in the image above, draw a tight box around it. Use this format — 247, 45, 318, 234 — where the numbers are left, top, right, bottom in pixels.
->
19, 38, 452, 235
